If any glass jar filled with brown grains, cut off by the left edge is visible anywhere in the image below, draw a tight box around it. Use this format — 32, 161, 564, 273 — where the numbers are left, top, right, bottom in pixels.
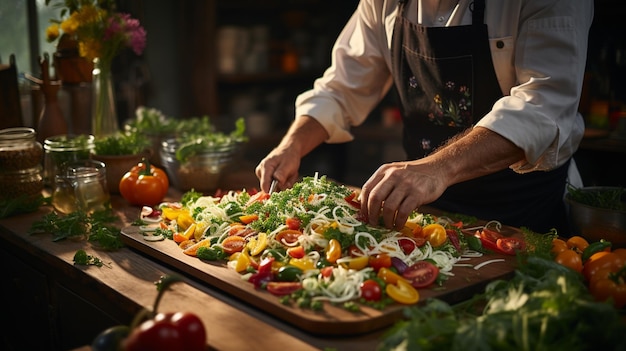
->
0, 127, 43, 200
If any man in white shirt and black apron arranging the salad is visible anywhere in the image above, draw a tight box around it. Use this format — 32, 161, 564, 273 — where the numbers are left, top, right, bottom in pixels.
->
256, 0, 593, 235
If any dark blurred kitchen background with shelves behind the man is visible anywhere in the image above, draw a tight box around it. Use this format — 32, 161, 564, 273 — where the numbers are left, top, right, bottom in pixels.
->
0, 0, 626, 186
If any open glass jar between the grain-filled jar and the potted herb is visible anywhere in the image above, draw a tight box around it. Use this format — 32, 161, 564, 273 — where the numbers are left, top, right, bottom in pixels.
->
43, 134, 95, 186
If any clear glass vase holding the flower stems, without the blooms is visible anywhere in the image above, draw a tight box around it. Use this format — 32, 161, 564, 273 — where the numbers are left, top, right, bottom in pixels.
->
91, 58, 119, 138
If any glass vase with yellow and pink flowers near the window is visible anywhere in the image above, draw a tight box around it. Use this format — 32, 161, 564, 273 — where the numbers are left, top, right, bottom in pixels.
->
46, 0, 146, 137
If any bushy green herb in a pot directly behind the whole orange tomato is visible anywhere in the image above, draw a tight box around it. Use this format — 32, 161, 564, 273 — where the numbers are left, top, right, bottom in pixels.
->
92, 131, 152, 194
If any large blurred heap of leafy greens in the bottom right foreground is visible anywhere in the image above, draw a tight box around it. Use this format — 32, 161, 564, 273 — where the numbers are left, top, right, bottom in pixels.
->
378, 256, 626, 351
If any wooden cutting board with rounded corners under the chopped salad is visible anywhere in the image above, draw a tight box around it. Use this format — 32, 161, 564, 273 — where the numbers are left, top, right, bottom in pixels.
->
122, 226, 516, 335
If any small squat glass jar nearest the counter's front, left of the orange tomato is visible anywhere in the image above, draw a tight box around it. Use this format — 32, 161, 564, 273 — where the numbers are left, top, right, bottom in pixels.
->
52, 160, 110, 214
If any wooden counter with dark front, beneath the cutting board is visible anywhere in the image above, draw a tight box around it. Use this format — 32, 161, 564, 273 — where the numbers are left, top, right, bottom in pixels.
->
0, 168, 382, 350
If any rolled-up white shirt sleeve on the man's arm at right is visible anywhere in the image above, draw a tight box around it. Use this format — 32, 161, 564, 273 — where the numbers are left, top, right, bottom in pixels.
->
477, 0, 593, 173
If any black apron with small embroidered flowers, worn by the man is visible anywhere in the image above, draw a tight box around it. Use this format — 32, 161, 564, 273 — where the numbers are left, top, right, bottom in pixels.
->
391, 0, 569, 236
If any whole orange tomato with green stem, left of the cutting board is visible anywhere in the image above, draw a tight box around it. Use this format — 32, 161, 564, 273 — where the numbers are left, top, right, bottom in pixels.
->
119, 160, 169, 206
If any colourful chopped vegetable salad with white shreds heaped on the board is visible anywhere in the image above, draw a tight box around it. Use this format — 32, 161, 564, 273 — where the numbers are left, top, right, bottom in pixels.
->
140, 174, 480, 310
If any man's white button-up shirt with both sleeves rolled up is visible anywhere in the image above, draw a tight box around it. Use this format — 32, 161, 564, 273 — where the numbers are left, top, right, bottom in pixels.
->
296, 0, 593, 173
